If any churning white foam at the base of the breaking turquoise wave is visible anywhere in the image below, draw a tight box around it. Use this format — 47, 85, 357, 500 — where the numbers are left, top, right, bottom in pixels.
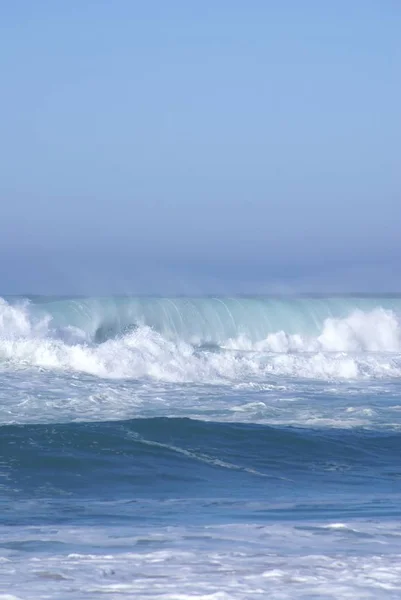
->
0, 299, 401, 392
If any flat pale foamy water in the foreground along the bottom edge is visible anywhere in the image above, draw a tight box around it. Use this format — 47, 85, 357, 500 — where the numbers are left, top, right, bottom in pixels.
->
0, 521, 401, 600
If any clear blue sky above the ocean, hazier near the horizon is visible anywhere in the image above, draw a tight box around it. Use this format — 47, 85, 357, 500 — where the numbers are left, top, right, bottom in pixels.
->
0, 0, 401, 294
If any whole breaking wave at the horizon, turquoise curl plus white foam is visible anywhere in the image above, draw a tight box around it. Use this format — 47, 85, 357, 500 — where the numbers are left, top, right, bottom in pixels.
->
0, 298, 401, 381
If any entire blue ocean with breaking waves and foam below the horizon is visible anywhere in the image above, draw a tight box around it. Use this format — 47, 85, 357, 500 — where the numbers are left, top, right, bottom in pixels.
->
0, 296, 401, 600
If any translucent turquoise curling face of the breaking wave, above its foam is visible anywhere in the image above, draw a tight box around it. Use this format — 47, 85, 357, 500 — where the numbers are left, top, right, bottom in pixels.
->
4, 297, 401, 350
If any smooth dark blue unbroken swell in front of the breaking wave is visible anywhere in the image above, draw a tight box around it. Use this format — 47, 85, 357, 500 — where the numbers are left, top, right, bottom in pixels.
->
0, 418, 401, 495
